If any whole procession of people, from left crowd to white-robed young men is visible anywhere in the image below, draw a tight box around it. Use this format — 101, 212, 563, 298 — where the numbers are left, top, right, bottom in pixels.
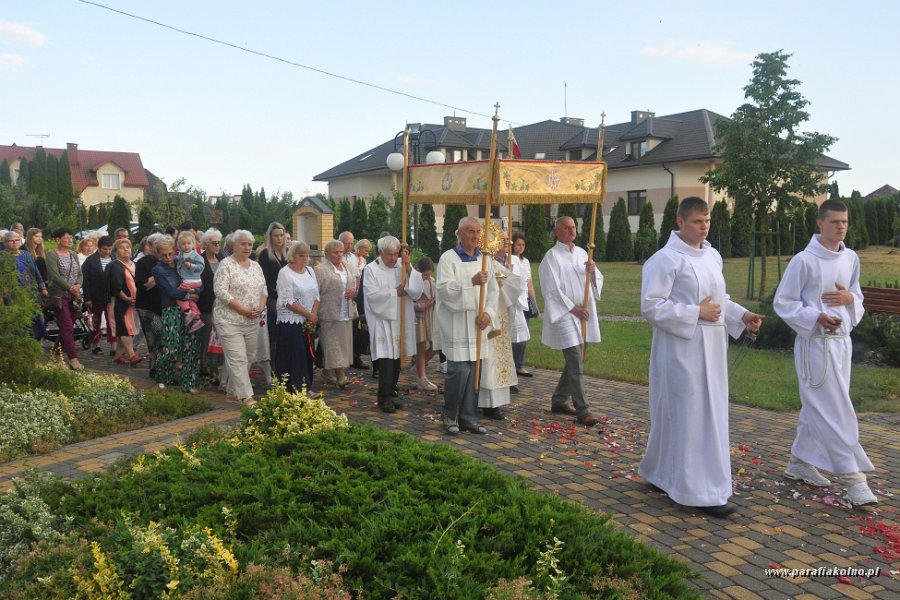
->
0, 197, 877, 517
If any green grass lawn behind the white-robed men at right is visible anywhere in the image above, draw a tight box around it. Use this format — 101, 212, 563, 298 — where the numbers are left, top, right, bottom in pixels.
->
526, 246, 900, 412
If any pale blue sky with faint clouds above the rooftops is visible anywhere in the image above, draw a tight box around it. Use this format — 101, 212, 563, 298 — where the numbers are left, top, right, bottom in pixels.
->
0, 0, 900, 198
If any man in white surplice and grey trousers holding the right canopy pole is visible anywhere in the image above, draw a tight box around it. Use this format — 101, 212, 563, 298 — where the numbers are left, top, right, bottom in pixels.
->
538, 217, 603, 427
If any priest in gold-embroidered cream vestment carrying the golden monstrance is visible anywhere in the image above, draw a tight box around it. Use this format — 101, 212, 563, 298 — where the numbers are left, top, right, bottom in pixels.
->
478, 235, 523, 421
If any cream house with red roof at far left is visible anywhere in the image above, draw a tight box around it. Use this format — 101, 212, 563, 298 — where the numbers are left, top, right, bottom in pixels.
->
0, 144, 150, 208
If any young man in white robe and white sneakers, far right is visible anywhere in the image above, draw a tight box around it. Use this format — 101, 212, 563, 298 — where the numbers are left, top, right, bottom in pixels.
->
774, 200, 878, 506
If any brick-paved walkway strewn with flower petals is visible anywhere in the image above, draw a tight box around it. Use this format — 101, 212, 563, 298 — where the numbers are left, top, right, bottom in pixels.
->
0, 357, 900, 599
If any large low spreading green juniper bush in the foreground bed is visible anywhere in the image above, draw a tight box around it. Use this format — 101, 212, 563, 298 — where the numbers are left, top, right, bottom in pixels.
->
0, 426, 694, 598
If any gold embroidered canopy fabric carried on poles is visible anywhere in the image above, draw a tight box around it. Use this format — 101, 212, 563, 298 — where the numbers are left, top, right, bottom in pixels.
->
409, 160, 606, 205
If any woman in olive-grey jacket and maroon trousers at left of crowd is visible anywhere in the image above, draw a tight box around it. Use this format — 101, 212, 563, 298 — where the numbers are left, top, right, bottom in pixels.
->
41, 227, 84, 371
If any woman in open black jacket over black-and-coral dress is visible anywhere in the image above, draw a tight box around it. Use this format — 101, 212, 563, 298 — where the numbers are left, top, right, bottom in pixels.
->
108, 238, 141, 365
